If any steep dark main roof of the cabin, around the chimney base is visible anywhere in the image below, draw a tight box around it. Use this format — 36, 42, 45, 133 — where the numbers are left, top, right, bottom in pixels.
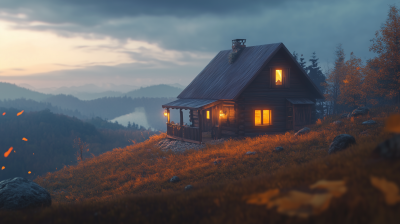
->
178, 43, 323, 100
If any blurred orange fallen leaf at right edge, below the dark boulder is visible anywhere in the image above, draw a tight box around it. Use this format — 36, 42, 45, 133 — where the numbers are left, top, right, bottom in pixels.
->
371, 176, 400, 205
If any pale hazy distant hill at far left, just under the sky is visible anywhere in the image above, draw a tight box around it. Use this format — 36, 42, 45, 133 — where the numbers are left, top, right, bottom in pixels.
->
0, 82, 50, 101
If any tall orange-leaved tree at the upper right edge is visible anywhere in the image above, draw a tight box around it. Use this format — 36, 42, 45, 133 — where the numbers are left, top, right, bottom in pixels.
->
368, 6, 400, 103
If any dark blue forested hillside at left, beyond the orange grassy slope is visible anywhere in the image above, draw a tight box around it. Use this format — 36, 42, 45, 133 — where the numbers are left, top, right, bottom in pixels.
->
0, 108, 159, 181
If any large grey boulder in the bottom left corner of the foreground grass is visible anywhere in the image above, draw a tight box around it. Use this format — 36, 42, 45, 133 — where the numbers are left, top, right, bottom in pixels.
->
0, 177, 51, 210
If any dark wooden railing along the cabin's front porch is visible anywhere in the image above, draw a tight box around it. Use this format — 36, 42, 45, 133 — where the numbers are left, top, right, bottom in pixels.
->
167, 124, 202, 143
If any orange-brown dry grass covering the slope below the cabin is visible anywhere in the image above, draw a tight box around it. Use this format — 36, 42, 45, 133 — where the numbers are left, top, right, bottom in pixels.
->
0, 107, 400, 223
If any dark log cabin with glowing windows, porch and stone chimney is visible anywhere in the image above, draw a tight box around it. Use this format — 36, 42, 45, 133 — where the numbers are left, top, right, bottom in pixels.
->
162, 39, 324, 143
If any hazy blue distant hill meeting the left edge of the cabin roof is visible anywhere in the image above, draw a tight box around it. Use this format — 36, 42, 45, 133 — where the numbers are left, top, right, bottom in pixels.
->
123, 84, 182, 98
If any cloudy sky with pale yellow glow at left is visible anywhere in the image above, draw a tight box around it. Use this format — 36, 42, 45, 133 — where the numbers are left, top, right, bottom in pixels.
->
0, 0, 400, 88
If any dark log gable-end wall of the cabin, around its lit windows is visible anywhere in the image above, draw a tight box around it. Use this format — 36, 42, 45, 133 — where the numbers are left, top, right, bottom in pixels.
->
237, 49, 315, 136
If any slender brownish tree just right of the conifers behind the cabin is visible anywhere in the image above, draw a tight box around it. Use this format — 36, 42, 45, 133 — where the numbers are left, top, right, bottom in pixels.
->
324, 44, 345, 114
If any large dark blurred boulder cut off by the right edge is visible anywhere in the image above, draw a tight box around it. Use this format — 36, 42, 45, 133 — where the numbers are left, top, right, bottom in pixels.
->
372, 135, 400, 159
